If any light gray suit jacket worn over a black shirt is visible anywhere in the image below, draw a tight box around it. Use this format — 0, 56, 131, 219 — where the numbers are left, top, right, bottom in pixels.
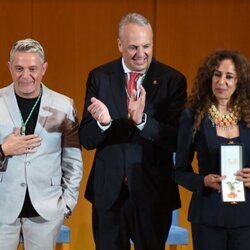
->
0, 83, 83, 223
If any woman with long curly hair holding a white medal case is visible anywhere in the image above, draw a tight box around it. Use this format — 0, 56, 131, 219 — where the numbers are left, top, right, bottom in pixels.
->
174, 50, 250, 250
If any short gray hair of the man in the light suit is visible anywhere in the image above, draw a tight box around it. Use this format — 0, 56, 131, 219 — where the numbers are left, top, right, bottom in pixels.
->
10, 38, 45, 63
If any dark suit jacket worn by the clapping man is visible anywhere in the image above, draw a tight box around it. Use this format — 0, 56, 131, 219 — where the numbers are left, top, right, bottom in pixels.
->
80, 59, 186, 210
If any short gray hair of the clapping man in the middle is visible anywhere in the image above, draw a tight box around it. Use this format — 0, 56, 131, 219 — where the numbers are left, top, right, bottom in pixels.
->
118, 13, 153, 39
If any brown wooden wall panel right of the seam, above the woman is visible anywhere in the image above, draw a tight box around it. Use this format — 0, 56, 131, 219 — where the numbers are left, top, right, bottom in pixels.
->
156, 0, 250, 93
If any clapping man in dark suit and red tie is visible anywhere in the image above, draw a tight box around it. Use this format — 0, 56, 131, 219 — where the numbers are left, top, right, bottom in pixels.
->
80, 13, 186, 250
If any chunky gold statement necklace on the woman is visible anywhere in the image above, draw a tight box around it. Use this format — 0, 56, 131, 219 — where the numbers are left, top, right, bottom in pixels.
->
208, 104, 240, 130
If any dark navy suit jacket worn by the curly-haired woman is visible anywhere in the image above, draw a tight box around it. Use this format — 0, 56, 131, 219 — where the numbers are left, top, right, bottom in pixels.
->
174, 109, 250, 227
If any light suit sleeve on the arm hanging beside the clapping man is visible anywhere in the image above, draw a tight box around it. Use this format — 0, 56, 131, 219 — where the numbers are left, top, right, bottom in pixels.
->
62, 99, 83, 210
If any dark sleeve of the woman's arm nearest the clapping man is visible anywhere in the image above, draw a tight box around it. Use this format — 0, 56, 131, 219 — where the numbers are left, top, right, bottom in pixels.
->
173, 109, 204, 193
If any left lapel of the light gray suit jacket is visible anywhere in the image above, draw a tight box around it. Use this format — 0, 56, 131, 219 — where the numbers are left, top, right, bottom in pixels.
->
3, 83, 21, 128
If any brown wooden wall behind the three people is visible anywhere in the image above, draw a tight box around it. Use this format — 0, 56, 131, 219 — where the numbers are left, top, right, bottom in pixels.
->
0, 0, 250, 250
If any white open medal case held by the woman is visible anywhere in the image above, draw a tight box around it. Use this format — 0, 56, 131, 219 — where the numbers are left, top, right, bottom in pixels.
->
221, 144, 246, 203
